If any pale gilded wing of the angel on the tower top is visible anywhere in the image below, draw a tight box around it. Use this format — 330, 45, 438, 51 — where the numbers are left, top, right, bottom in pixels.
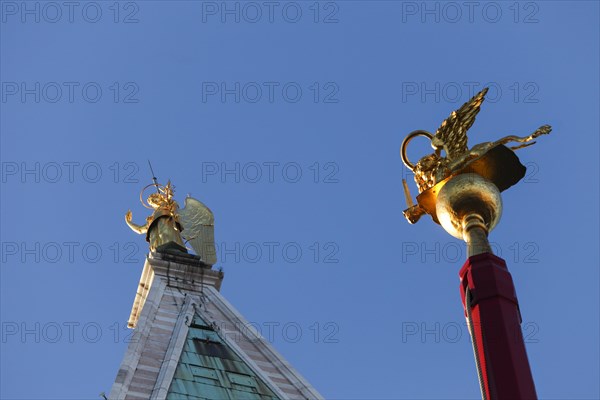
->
178, 197, 217, 265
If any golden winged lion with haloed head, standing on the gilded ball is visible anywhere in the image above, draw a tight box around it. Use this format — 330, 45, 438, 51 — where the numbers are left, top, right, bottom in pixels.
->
400, 88, 552, 223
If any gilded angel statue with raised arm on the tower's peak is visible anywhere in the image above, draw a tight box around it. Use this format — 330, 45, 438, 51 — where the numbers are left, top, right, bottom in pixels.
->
125, 181, 217, 265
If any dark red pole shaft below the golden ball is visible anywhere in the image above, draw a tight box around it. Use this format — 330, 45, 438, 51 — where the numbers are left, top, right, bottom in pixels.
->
459, 253, 537, 400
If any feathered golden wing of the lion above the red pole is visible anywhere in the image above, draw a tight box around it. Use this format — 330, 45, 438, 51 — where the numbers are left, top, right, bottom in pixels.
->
435, 88, 488, 160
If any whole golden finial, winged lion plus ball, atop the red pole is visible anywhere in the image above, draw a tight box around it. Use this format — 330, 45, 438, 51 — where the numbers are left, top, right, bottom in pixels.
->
400, 88, 552, 255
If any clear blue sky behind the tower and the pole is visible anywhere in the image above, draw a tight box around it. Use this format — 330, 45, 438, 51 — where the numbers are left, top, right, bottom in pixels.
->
0, 1, 600, 399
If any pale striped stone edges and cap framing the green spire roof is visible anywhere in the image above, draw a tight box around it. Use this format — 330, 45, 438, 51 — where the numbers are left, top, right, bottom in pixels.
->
109, 252, 322, 400
